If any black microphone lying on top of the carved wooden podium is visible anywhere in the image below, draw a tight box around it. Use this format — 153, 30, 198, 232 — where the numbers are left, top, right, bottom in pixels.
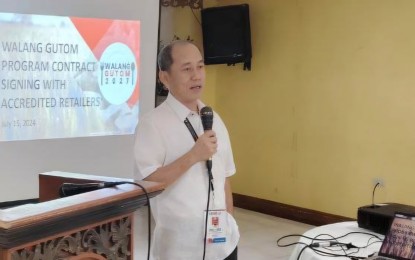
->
59, 181, 128, 198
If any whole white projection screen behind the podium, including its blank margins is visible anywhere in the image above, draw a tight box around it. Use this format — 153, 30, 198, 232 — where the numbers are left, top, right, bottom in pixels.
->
0, 0, 159, 202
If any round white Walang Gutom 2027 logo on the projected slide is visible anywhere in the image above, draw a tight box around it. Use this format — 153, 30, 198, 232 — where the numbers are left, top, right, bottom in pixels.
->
98, 42, 138, 105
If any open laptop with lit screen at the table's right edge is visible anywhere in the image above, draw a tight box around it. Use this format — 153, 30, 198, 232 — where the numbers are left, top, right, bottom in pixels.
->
367, 213, 415, 260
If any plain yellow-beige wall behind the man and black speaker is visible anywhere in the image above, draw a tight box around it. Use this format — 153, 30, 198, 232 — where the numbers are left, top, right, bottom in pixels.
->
163, 0, 415, 217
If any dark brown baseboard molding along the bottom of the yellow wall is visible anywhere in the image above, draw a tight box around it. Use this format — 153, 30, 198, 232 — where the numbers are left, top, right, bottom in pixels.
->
233, 193, 356, 226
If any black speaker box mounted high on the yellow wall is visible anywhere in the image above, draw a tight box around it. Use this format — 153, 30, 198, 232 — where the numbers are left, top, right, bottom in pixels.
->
201, 4, 252, 70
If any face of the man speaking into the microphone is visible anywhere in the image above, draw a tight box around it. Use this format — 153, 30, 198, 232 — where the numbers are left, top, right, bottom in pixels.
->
160, 44, 205, 110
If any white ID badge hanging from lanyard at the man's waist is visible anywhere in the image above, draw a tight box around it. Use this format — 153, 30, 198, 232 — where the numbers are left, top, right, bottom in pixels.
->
206, 209, 228, 244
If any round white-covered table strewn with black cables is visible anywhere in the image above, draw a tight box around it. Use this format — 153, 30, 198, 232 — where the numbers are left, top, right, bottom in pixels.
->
288, 221, 384, 260
